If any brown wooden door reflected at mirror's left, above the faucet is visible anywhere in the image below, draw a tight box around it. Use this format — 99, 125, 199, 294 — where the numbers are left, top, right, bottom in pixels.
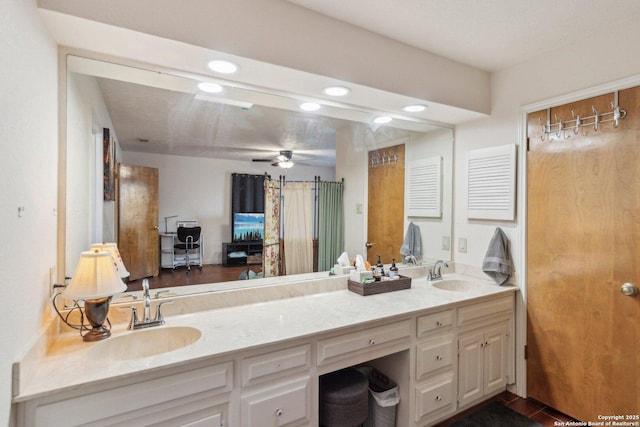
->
118, 164, 159, 280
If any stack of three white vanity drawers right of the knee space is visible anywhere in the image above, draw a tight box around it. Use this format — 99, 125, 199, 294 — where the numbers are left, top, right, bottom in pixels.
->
414, 309, 457, 425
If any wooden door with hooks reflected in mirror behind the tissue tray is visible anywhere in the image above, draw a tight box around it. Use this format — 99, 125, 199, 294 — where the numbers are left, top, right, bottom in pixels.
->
367, 144, 404, 265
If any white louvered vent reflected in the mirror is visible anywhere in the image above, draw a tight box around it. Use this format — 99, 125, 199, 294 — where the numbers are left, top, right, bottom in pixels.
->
407, 156, 442, 217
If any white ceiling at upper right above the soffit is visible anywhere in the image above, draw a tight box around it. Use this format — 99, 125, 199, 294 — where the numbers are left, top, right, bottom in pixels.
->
288, 0, 640, 71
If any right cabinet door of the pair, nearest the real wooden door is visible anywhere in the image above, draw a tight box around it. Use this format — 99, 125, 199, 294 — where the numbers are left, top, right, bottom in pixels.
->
484, 324, 508, 394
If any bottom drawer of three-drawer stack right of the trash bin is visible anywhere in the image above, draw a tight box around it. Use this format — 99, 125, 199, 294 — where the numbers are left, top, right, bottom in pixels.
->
416, 372, 456, 421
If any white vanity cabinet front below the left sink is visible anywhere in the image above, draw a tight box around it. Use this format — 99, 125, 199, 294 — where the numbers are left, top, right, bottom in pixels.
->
18, 362, 233, 427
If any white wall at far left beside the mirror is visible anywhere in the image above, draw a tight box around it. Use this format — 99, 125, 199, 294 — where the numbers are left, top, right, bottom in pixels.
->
0, 0, 58, 425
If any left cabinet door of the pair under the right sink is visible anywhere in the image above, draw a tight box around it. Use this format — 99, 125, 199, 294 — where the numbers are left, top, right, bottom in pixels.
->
458, 331, 484, 406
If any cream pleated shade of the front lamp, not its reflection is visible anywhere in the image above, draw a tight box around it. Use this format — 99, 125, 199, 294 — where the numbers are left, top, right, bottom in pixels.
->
62, 250, 127, 300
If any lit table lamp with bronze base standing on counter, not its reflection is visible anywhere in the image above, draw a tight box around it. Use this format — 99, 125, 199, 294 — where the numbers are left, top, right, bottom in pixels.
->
62, 249, 127, 341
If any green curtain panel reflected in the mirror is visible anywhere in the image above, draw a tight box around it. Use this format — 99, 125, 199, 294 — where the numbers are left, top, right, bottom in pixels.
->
318, 182, 344, 271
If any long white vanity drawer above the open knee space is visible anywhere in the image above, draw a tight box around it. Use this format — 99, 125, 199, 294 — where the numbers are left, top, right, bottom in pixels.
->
318, 319, 411, 365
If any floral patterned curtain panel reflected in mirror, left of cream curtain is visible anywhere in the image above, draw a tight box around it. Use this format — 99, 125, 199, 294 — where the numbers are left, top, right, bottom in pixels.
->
262, 179, 281, 277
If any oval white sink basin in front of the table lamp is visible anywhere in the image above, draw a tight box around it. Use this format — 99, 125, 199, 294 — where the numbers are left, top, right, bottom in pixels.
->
89, 326, 202, 360
